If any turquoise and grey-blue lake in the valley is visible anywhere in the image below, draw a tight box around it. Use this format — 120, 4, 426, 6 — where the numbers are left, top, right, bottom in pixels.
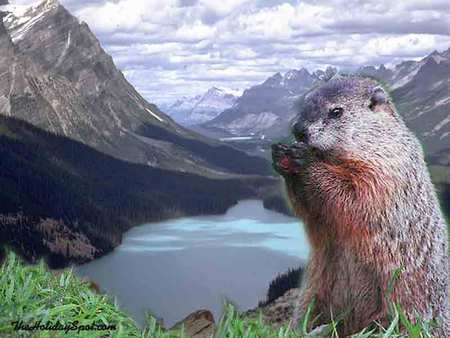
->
76, 200, 309, 326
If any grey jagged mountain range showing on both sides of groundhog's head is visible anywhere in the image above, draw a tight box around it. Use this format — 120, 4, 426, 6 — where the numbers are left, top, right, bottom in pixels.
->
196, 48, 450, 163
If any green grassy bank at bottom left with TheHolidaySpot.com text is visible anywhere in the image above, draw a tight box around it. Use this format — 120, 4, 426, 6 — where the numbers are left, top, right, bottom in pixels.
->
0, 253, 180, 338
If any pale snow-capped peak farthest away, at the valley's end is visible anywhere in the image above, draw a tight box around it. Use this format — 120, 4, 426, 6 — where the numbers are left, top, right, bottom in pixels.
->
161, 87, 240, 126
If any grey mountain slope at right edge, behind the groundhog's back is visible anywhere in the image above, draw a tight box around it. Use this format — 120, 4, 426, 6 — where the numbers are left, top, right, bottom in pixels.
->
390, 48, 450, 219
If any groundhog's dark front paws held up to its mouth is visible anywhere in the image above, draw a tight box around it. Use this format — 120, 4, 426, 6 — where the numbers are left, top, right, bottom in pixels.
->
272, 143, 305, 176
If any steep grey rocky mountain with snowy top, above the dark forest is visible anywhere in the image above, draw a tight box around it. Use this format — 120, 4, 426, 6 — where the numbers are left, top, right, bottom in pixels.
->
0, 0, 270, 177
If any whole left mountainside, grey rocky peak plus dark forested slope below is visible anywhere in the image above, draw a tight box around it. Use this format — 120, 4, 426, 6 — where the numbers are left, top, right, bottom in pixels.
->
0, 0, 280, 267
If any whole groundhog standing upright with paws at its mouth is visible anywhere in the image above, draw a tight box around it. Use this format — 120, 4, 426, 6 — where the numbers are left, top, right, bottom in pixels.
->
272, 77, 450, 337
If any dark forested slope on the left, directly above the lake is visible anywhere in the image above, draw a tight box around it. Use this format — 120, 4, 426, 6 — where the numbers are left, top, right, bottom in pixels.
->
0, 116, 277, 267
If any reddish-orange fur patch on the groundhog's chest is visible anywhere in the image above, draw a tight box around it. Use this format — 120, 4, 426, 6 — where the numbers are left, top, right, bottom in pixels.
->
302, 158, 393, 251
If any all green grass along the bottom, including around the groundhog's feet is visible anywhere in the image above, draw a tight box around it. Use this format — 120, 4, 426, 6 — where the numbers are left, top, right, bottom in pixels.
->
0, 253, 442, 338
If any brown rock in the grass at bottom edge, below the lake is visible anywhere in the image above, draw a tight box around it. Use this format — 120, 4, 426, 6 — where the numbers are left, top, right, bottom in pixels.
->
172, 310, 216, 338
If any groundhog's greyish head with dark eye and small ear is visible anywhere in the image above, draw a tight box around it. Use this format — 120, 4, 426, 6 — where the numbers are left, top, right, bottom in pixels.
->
292, 77, 399, 151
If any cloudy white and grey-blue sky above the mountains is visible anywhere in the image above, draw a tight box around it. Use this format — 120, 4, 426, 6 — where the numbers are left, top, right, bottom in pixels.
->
10, 0, 450, 102
